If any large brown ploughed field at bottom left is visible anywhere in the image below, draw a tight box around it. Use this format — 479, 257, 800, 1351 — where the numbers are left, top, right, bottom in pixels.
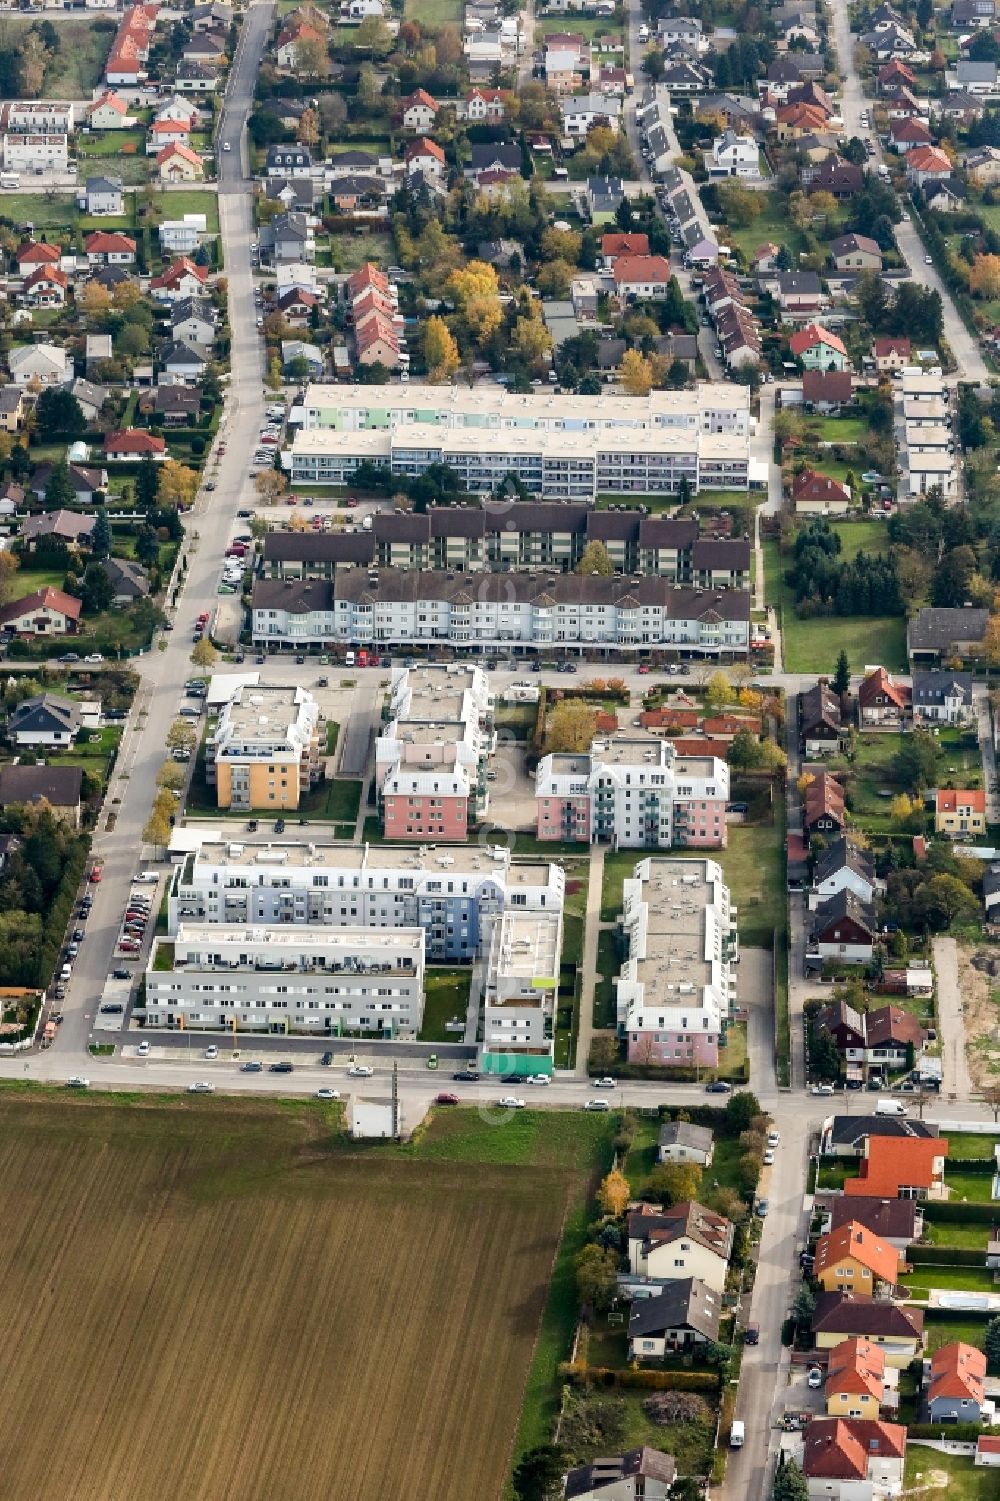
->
0, 1087, 585, 1501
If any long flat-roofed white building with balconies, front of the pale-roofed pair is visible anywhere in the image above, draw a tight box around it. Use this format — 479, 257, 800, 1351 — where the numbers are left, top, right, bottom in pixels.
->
290, 423, 749, 503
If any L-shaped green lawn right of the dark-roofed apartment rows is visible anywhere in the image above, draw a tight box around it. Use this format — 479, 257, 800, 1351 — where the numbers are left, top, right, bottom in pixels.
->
764, 540, 907, 672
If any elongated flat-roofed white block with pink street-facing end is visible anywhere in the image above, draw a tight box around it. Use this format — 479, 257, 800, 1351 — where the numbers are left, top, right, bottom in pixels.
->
616, 859, 739, 1067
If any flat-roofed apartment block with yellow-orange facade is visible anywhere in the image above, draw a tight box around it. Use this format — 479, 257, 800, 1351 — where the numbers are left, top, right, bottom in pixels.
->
206, 683, 320, 812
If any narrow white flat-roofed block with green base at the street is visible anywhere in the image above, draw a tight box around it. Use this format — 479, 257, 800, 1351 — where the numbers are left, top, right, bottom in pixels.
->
479, 910, 563, 1075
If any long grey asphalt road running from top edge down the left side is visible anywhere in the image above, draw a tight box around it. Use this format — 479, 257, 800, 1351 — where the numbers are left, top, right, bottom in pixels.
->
44, 5, 272, 1073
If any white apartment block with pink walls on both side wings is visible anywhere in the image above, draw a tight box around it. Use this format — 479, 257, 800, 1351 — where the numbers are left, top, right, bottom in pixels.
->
535, 734, 730, 850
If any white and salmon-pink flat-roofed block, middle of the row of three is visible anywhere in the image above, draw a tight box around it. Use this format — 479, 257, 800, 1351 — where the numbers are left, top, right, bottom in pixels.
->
375, 663, 495, 839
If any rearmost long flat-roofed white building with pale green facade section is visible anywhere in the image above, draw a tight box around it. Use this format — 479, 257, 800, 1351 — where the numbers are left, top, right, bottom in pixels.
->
303, 381, 751, 437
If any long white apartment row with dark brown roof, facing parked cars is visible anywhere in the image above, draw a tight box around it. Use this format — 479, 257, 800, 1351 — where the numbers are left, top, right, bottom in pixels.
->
252, 567, 751, 659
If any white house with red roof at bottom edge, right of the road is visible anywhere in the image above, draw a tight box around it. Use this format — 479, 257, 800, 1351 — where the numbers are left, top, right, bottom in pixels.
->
802, 1417, 907, 1501
